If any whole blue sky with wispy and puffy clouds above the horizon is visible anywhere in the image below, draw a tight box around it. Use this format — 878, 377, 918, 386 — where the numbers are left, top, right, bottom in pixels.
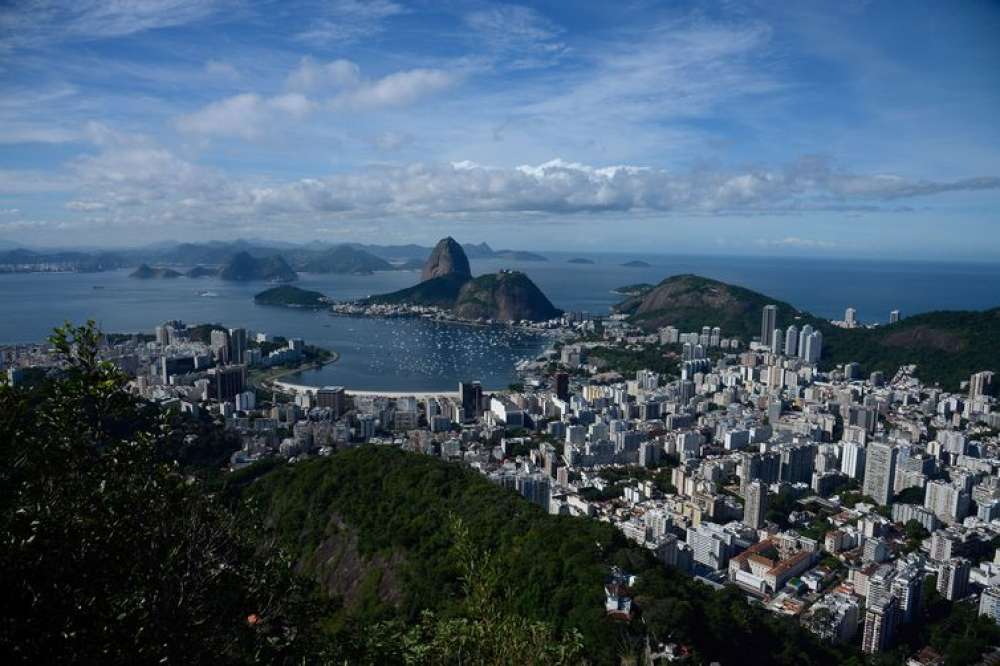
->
0, 0, 1000, 261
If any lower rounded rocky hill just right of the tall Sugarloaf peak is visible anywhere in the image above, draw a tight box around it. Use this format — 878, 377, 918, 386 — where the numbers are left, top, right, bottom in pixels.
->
453, 271, 562, 321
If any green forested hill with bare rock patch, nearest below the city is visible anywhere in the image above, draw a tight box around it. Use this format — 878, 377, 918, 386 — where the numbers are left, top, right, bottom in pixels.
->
230, 446, 853, 664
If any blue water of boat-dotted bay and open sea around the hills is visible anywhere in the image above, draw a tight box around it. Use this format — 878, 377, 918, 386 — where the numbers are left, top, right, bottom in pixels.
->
0, 252, 1000, 391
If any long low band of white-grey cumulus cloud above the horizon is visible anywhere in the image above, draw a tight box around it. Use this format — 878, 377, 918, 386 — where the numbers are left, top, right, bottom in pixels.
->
52, 136, 1000, 232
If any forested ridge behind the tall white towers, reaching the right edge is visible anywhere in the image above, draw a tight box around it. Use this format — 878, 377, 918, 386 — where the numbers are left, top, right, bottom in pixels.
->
616, 275, 1000, 390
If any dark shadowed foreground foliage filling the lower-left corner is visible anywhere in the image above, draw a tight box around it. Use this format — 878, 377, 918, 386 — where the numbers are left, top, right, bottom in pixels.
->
0, 323, 318, 663
